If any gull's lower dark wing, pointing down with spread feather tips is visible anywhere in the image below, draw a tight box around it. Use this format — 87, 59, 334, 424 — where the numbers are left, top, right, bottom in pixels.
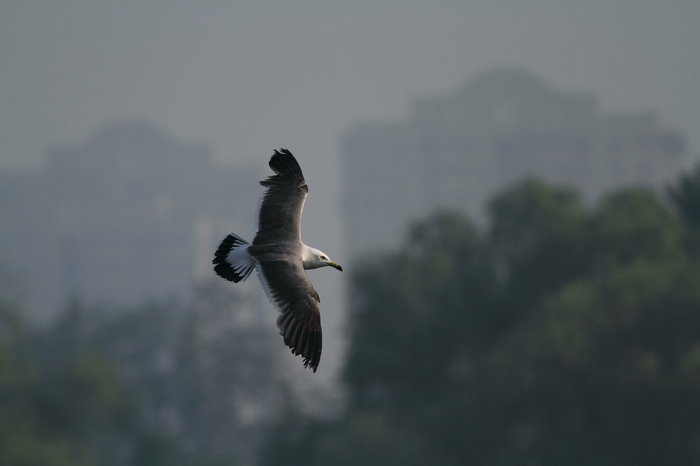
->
253, 258, 322, 372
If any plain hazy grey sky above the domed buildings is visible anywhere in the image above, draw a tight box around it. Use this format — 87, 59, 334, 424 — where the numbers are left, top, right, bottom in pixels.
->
0, 0, 700, 173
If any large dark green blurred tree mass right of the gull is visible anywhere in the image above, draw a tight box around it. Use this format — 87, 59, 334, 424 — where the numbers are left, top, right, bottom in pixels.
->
263, 173, 700, 466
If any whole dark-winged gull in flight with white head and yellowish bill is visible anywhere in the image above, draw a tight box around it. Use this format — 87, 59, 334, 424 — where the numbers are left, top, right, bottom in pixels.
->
212, 149, 343, 372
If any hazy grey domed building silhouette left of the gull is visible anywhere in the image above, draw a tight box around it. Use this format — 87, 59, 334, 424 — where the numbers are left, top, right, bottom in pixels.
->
0, 121, 262, 317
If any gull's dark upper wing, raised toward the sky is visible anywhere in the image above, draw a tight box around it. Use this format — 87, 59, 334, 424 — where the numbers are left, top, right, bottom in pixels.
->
253, 149, 309, 244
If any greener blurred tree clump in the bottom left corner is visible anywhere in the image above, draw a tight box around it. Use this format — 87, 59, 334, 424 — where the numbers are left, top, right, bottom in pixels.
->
0, 305, 135, 466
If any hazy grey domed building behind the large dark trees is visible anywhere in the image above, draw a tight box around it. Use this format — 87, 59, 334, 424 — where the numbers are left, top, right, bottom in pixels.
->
342, 70, 684, 254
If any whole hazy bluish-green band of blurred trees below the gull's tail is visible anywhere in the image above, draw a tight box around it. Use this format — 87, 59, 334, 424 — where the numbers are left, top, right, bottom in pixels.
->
0, 283, 287, 466
